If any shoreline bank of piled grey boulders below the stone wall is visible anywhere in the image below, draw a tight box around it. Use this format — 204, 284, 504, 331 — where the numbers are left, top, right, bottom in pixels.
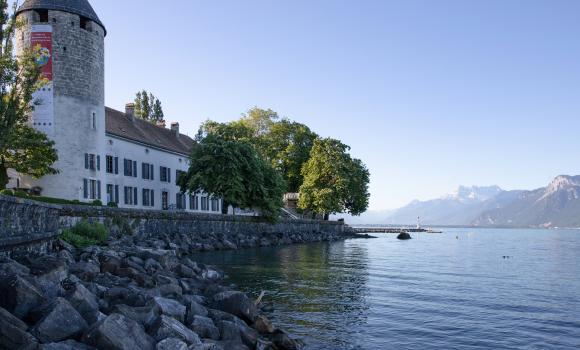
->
0, 232, 312, 350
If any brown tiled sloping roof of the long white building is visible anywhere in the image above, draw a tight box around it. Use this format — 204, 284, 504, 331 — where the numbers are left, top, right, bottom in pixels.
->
105, 107, 195, 156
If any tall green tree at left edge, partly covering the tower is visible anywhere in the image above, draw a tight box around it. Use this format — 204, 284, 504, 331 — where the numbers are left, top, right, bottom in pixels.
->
0, 0, 58, 189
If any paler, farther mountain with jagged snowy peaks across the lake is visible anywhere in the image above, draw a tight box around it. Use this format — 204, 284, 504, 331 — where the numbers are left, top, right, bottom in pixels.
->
386, 186, 517, 225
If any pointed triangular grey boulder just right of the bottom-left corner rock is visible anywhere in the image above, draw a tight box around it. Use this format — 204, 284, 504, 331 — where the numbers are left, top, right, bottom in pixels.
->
32, 298, 88, 343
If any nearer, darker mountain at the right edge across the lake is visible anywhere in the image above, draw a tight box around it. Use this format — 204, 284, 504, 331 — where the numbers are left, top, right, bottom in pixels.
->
471, 175, 580, 227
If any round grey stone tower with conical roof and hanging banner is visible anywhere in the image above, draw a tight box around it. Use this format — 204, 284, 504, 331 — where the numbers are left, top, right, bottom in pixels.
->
16, 0, 107, 201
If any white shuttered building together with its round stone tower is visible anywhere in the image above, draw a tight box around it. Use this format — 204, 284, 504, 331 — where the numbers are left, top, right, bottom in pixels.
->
9, 0, 222, 213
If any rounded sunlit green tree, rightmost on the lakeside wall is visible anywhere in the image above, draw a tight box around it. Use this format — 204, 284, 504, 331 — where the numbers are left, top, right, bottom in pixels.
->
298, 138, 370, 217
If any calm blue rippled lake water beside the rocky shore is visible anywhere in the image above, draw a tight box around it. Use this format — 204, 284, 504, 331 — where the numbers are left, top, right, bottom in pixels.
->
196, 229, 580, 349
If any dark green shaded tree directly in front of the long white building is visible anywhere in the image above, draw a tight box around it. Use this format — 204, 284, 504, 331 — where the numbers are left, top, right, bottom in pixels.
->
179, 129, 285, 220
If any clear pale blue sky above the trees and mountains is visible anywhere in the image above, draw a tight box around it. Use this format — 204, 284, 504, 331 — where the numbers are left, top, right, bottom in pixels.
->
91, 0, 580, 210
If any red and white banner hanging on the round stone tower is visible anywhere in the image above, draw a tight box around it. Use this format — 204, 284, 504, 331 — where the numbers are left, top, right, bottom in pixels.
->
30, 25, 54, 136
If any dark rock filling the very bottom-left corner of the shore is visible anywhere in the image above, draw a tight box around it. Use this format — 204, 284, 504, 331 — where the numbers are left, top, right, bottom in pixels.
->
0, 308, 38, 349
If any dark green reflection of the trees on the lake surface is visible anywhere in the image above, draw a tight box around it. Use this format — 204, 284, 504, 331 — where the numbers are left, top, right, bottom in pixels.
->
195, 242, 370, 349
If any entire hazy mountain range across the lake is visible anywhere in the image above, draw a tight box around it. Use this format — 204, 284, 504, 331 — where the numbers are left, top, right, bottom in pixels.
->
355, 175, 580, 228
